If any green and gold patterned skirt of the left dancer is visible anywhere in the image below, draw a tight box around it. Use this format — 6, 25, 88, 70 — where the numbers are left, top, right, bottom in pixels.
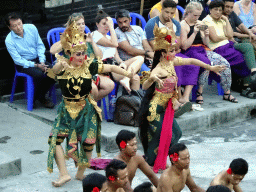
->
47, 98, 101, 173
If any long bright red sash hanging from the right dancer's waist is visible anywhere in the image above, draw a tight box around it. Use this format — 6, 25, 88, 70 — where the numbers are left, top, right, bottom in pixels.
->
153, 99, 174, 173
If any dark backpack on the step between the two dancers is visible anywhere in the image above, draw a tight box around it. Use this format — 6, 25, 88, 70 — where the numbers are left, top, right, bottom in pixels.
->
114, 91, 143, 127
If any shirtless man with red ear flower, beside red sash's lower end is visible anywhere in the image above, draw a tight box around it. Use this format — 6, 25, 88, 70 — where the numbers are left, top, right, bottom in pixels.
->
157, 143, 205, 192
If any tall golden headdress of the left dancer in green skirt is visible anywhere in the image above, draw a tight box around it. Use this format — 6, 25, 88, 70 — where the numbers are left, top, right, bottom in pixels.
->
60, 21, 87, 54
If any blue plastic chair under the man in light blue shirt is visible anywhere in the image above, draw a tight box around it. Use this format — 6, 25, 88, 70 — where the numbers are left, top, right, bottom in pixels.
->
10, 68, 57, 111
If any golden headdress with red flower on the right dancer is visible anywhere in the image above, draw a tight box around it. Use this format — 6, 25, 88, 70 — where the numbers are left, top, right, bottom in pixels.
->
153, 24, 177, 51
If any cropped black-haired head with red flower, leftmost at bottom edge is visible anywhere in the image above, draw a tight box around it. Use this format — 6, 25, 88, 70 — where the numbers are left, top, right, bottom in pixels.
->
82, 173, 107, 192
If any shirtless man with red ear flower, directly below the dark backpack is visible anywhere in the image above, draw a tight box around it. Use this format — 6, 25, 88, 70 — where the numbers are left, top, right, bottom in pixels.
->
115, 130, 158, 191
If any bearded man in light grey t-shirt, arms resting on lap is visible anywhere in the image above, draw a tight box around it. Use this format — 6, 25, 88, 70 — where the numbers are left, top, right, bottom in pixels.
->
115, 9, 154, 67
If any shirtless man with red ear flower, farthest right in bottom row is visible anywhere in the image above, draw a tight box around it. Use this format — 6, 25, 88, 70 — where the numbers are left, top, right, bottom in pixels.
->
210, 158, 248, 192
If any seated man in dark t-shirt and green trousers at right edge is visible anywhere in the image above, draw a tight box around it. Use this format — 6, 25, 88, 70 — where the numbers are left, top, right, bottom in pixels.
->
223, 0, 256, 98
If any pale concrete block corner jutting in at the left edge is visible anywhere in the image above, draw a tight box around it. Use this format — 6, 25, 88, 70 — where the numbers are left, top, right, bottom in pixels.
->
0, 152, 21, 178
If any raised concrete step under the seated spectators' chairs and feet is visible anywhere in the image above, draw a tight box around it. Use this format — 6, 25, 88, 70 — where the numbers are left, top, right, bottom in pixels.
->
5, 85, 256, 152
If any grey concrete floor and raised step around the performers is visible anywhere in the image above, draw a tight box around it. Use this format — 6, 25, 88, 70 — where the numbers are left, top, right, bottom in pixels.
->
0, 86, 256, 192
